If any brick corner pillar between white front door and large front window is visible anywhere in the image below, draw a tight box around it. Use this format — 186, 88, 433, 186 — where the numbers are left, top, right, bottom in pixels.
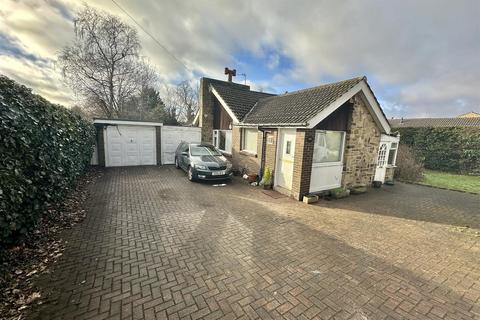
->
292, 129, 315, 200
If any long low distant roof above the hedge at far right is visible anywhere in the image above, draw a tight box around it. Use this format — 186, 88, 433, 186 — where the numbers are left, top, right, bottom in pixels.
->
389, 118, 480, 128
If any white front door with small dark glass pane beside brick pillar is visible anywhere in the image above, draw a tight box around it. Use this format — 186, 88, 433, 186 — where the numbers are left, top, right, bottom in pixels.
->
275, 129, 296, 190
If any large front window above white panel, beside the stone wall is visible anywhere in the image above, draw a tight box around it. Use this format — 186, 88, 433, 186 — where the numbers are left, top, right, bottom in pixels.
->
313, 130, 345, 163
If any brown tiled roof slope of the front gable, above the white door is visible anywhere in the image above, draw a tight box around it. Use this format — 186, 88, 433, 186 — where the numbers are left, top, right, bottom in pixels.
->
243, 77, 365, 125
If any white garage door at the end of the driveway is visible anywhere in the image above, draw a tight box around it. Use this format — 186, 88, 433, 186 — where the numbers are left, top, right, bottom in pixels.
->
105, 125, 157, 167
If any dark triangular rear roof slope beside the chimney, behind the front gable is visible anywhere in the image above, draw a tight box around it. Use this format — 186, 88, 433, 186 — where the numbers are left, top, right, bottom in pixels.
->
211, 82, 275, 120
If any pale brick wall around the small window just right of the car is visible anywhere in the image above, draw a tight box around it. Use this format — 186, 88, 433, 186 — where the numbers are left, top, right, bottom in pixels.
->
231, 126, 263, 174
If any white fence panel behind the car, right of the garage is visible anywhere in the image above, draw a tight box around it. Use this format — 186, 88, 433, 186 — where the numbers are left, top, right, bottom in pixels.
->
161, 126, 202, 164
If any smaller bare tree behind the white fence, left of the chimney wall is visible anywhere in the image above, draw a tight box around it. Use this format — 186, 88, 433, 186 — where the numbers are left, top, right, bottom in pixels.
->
165, 80, 198, 124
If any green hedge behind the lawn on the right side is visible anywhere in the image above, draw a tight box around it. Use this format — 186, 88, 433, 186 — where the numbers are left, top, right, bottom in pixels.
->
398, 127, 480, 175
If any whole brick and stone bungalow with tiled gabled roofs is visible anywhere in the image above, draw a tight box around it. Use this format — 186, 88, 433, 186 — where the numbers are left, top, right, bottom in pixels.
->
195, 77, 399, 200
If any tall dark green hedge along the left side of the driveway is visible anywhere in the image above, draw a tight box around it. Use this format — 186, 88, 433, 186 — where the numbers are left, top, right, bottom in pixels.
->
0, 75, 95, 248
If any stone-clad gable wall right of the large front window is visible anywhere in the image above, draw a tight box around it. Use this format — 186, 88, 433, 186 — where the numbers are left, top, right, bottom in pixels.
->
342, 93, 380, 188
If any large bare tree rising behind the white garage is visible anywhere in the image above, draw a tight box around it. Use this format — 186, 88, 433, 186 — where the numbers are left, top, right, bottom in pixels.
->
58, 6, 155, 117
